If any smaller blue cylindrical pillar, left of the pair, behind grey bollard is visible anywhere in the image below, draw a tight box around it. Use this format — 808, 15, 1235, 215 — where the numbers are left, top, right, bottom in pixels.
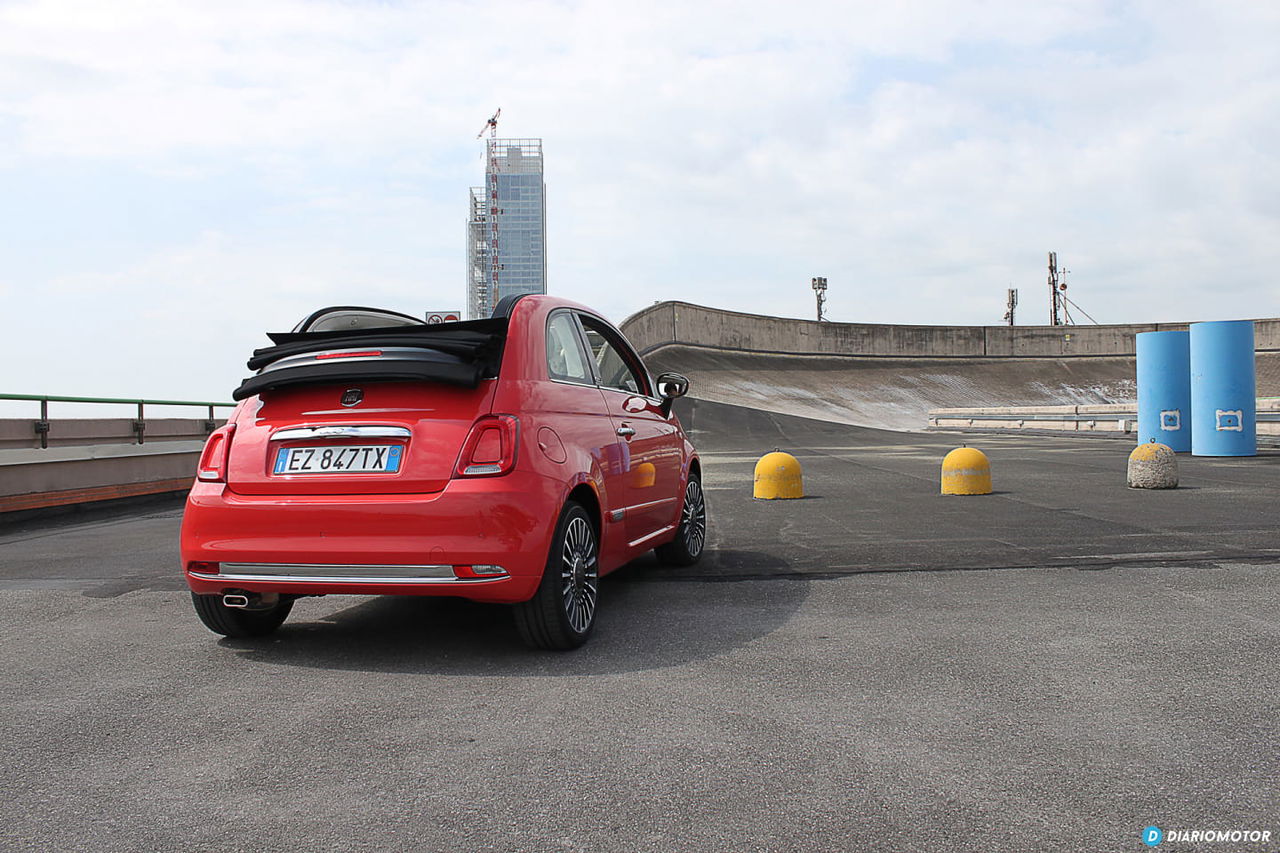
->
1137, 332, 1192, 453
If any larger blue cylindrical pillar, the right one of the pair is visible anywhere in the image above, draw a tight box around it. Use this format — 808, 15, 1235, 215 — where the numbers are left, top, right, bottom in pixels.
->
1190, 320, 1258, 456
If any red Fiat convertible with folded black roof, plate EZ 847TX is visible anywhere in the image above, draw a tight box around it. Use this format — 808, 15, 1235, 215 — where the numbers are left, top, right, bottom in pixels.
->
182, 296, 707, 648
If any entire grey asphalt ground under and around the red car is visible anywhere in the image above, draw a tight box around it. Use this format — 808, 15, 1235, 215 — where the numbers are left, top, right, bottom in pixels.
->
0, 405, 1280, 850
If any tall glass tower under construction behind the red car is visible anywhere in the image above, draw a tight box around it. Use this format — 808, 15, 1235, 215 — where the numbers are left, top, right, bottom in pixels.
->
467, 138, 547, 319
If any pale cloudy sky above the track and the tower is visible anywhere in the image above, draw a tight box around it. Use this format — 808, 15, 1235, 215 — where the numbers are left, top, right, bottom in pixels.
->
0, 0, 1280, 400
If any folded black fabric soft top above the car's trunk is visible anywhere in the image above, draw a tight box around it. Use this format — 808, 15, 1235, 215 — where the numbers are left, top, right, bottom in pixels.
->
232, 318, 507, 400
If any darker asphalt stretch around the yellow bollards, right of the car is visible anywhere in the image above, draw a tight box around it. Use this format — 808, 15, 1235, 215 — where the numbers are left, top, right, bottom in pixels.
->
662, 401, 1280, 578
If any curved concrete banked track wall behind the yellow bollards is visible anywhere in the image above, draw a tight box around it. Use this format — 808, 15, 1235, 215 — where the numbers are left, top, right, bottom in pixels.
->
622, 302, 1280, 429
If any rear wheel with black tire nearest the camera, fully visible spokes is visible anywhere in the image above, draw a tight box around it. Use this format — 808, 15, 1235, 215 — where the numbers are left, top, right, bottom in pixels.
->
515, 501, 600, 651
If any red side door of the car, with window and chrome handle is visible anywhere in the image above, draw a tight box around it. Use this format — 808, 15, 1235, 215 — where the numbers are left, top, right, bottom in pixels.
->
579, 314, 682, 544
